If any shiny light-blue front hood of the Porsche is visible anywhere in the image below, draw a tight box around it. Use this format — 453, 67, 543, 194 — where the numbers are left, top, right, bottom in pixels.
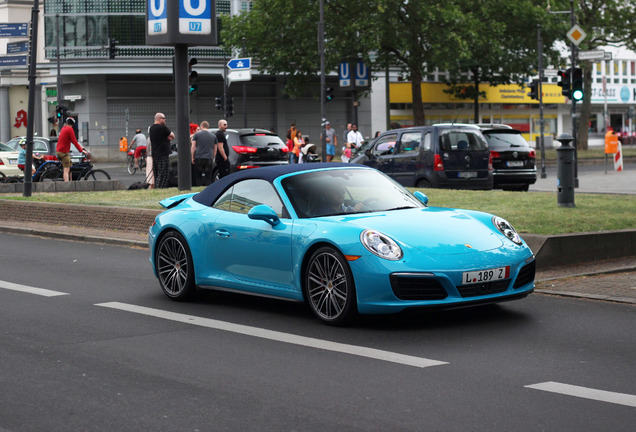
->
343, 207, 503, 255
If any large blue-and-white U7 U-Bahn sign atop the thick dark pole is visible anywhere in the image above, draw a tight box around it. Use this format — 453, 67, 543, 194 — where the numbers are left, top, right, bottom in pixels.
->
146, 0, 216, 46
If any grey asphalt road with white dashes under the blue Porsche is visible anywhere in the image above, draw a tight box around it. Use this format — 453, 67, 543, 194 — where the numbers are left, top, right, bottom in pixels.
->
0, 234, 636, 432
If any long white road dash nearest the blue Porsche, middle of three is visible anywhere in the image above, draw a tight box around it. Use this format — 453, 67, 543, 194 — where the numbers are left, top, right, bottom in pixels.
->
96, 302, 448, 368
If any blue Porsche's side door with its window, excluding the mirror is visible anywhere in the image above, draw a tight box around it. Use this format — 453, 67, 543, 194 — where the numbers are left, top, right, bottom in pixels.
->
212, 179, 295, 294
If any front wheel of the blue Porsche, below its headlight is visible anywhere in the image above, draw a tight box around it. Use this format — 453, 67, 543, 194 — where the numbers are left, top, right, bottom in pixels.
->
304, 246, 357, 325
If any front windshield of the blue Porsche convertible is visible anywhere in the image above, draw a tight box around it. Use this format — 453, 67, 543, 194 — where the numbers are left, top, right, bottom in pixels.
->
282, 169, 424, 218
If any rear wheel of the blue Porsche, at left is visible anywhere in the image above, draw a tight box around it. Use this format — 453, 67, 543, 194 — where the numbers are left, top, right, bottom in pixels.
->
155, 231, 195, 301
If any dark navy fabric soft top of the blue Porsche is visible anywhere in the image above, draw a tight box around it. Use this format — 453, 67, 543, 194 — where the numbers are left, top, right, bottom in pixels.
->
193, 162, 360, 206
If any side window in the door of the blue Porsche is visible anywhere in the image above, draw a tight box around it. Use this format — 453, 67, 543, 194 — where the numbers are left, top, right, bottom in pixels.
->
212, 179, 284, 217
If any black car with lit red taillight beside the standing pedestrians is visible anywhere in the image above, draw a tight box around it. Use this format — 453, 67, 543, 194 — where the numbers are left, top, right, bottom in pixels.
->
170, 129, 289, 186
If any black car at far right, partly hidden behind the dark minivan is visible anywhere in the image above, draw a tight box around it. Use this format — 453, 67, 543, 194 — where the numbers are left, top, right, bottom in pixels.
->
478, 124, 537, 191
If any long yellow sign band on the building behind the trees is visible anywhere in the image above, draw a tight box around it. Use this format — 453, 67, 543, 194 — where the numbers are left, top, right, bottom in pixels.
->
390, 83, 566, 104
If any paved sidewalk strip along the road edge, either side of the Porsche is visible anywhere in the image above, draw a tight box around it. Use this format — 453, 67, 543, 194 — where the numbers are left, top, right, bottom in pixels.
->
0, 221, 636, 305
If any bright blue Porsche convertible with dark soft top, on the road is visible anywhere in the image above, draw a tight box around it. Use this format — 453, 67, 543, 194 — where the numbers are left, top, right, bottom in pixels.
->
149, 163, 535, 325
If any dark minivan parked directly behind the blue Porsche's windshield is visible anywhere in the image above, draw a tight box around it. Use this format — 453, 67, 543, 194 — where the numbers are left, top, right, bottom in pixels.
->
350, 124, 493, 190
